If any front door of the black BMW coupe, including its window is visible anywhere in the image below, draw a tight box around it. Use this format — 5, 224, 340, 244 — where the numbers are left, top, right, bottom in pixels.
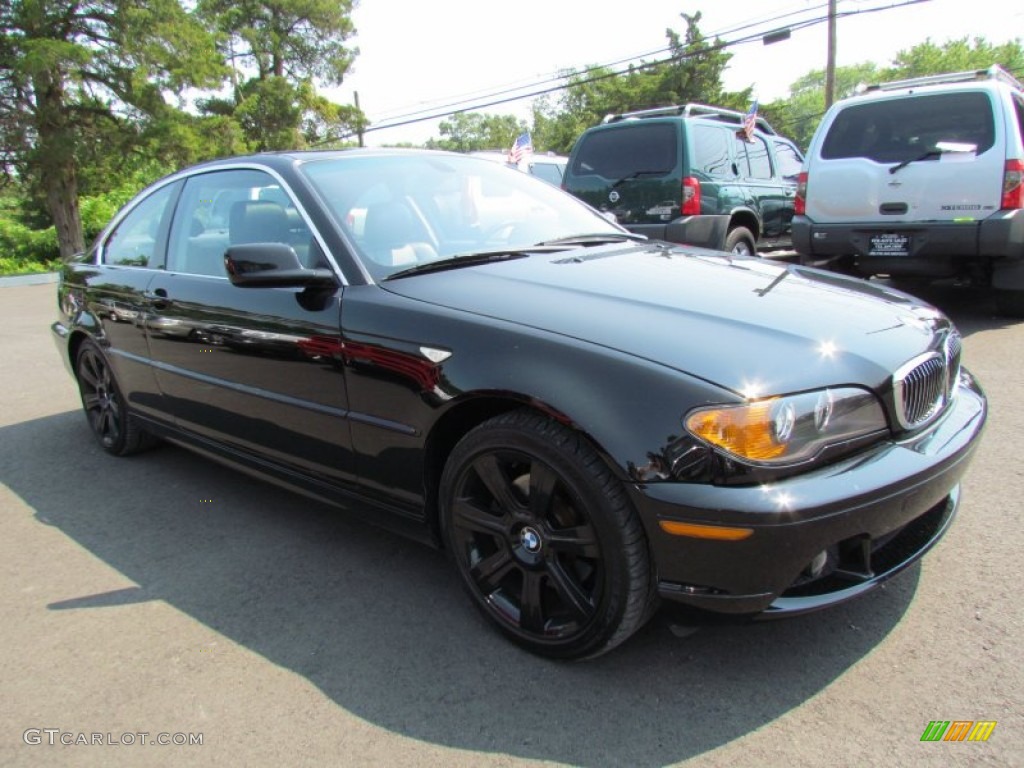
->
147, 169, 352, 480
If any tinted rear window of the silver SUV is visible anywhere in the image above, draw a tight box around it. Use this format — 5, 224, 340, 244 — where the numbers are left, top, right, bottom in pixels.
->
821, 91, 995, 163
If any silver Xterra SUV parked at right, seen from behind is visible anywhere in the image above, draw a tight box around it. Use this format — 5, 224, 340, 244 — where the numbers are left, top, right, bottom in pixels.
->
793, 67, 1024, 316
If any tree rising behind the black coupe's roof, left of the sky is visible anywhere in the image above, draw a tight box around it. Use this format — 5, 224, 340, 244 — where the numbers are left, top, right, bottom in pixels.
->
197, 0, 366, 150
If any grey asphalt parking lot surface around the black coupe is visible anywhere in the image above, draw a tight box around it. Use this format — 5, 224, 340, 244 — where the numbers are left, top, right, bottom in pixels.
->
0, 284, 1024, 767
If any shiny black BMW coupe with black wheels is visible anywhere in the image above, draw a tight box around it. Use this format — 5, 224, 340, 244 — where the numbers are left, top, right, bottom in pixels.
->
52, 150, 986, 658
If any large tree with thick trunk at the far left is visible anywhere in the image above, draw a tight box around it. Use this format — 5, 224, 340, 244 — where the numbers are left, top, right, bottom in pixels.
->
0, 0, 224, 257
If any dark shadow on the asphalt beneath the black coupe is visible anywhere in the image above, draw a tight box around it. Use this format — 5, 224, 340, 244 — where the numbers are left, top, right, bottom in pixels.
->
0, 412, 920, 766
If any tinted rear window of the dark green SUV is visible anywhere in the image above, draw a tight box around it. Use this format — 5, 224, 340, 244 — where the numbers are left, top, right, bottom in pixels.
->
572, 123, 679, 179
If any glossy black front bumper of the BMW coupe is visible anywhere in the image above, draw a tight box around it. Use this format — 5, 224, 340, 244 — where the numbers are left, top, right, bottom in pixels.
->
630, 374, 987, 615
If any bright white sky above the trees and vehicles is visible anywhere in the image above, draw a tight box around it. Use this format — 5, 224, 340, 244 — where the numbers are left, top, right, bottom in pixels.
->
326, 0, 1024, 148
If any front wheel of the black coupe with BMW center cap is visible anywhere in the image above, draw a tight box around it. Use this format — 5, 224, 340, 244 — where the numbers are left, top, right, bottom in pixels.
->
440, 411, 656, 658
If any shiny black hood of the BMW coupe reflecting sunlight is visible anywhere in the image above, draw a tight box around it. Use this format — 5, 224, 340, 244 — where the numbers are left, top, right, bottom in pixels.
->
383, 243, 950, 395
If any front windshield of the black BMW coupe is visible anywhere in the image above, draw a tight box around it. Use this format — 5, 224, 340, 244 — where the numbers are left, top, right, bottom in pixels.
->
302, 153, 628, 280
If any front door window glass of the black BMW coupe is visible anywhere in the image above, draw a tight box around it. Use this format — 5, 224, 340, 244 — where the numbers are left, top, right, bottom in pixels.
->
167, 170, 318, 278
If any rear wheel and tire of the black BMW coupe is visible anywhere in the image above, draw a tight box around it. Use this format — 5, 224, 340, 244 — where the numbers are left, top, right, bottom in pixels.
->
75, 340, 154, 456
